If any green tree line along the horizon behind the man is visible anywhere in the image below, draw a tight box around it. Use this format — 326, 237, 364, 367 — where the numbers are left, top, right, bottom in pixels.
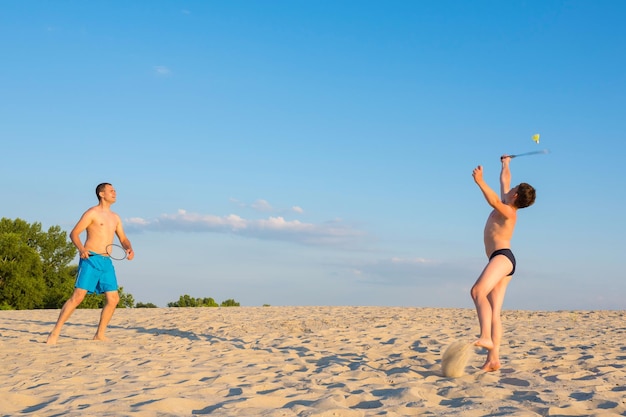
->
0, 217, 239, 310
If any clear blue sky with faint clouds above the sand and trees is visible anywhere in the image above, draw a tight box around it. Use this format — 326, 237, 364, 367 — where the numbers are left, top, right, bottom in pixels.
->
0, 0, 626, 310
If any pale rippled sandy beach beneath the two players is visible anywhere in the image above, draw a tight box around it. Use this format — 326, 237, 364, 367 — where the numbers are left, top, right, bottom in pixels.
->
0, 307, 626, 417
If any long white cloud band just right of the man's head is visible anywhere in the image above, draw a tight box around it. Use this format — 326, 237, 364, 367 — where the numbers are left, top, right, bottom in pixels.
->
126, 210, 366, 247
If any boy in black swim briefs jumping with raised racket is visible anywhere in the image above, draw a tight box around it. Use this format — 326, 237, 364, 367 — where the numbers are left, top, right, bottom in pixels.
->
471, 155, 535, 372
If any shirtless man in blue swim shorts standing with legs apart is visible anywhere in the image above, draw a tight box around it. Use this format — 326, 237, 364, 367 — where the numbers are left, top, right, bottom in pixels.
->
46, 183, 135, 344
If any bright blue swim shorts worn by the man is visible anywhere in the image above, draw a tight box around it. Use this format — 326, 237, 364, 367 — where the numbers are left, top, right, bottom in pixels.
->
74, 252, 117, 294
